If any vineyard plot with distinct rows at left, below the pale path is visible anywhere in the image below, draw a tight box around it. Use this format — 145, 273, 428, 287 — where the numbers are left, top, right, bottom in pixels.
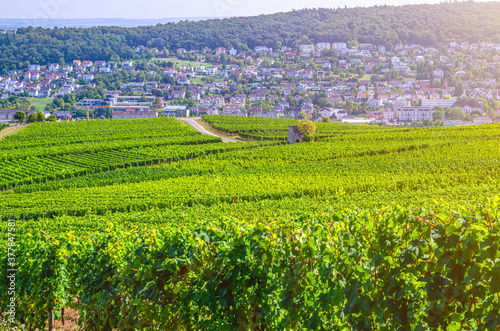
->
0, 118, 225, 189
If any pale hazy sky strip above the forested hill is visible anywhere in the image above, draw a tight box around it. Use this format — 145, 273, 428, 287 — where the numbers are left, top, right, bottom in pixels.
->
0, 0, 492, 20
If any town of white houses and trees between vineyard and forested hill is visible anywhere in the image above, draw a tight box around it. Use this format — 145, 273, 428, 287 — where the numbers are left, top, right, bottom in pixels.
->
0, 38, 500, 126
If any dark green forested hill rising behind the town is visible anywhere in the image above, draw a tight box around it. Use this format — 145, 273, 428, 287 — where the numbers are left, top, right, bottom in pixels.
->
0, 2, 500, 69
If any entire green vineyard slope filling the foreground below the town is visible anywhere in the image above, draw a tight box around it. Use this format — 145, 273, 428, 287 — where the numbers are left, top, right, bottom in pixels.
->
0, 117, 500, 331
